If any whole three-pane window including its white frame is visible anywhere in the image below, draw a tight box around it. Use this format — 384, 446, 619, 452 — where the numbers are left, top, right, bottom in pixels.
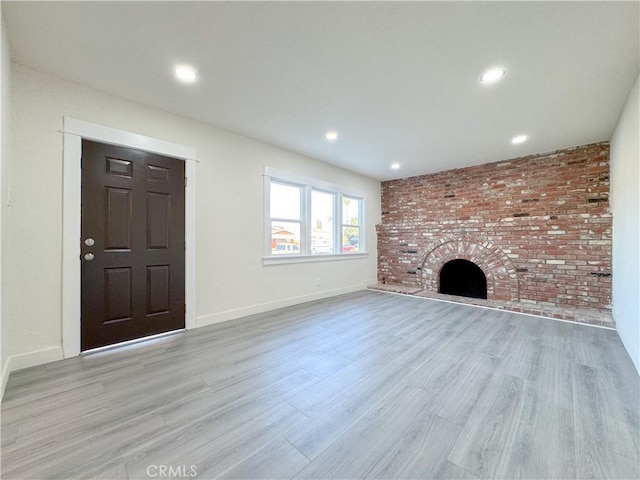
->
265, 167, 365, 261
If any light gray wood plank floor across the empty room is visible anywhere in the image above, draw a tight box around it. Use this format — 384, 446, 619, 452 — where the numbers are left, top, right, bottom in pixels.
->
2, 291, 640, 479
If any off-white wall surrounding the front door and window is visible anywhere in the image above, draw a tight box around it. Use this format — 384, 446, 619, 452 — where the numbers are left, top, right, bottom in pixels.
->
7, 64, 380, 365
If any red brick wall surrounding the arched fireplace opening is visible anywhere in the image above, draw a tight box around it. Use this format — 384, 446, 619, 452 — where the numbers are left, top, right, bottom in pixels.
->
377, 142, 611, 312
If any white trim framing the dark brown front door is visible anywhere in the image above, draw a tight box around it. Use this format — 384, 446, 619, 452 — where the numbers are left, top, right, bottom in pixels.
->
62, 117, 197, 358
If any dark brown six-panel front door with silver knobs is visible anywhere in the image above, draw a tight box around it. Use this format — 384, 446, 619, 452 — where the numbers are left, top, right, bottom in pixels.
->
80, 140, 185, 351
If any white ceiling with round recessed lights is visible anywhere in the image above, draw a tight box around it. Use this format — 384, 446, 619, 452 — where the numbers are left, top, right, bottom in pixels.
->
2, 1, 640, 179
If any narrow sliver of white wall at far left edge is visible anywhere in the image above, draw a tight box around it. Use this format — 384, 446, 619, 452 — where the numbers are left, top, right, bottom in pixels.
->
0, 11, 11, 398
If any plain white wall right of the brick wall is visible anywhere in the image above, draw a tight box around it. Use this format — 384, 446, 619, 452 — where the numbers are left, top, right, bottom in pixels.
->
611, 76, 640, 372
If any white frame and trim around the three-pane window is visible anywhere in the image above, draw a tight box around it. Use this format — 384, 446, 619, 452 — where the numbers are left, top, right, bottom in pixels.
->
263, 166, 368, 265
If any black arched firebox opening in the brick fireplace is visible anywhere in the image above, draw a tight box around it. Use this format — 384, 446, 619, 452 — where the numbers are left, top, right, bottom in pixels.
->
438, 259, 487, 299
